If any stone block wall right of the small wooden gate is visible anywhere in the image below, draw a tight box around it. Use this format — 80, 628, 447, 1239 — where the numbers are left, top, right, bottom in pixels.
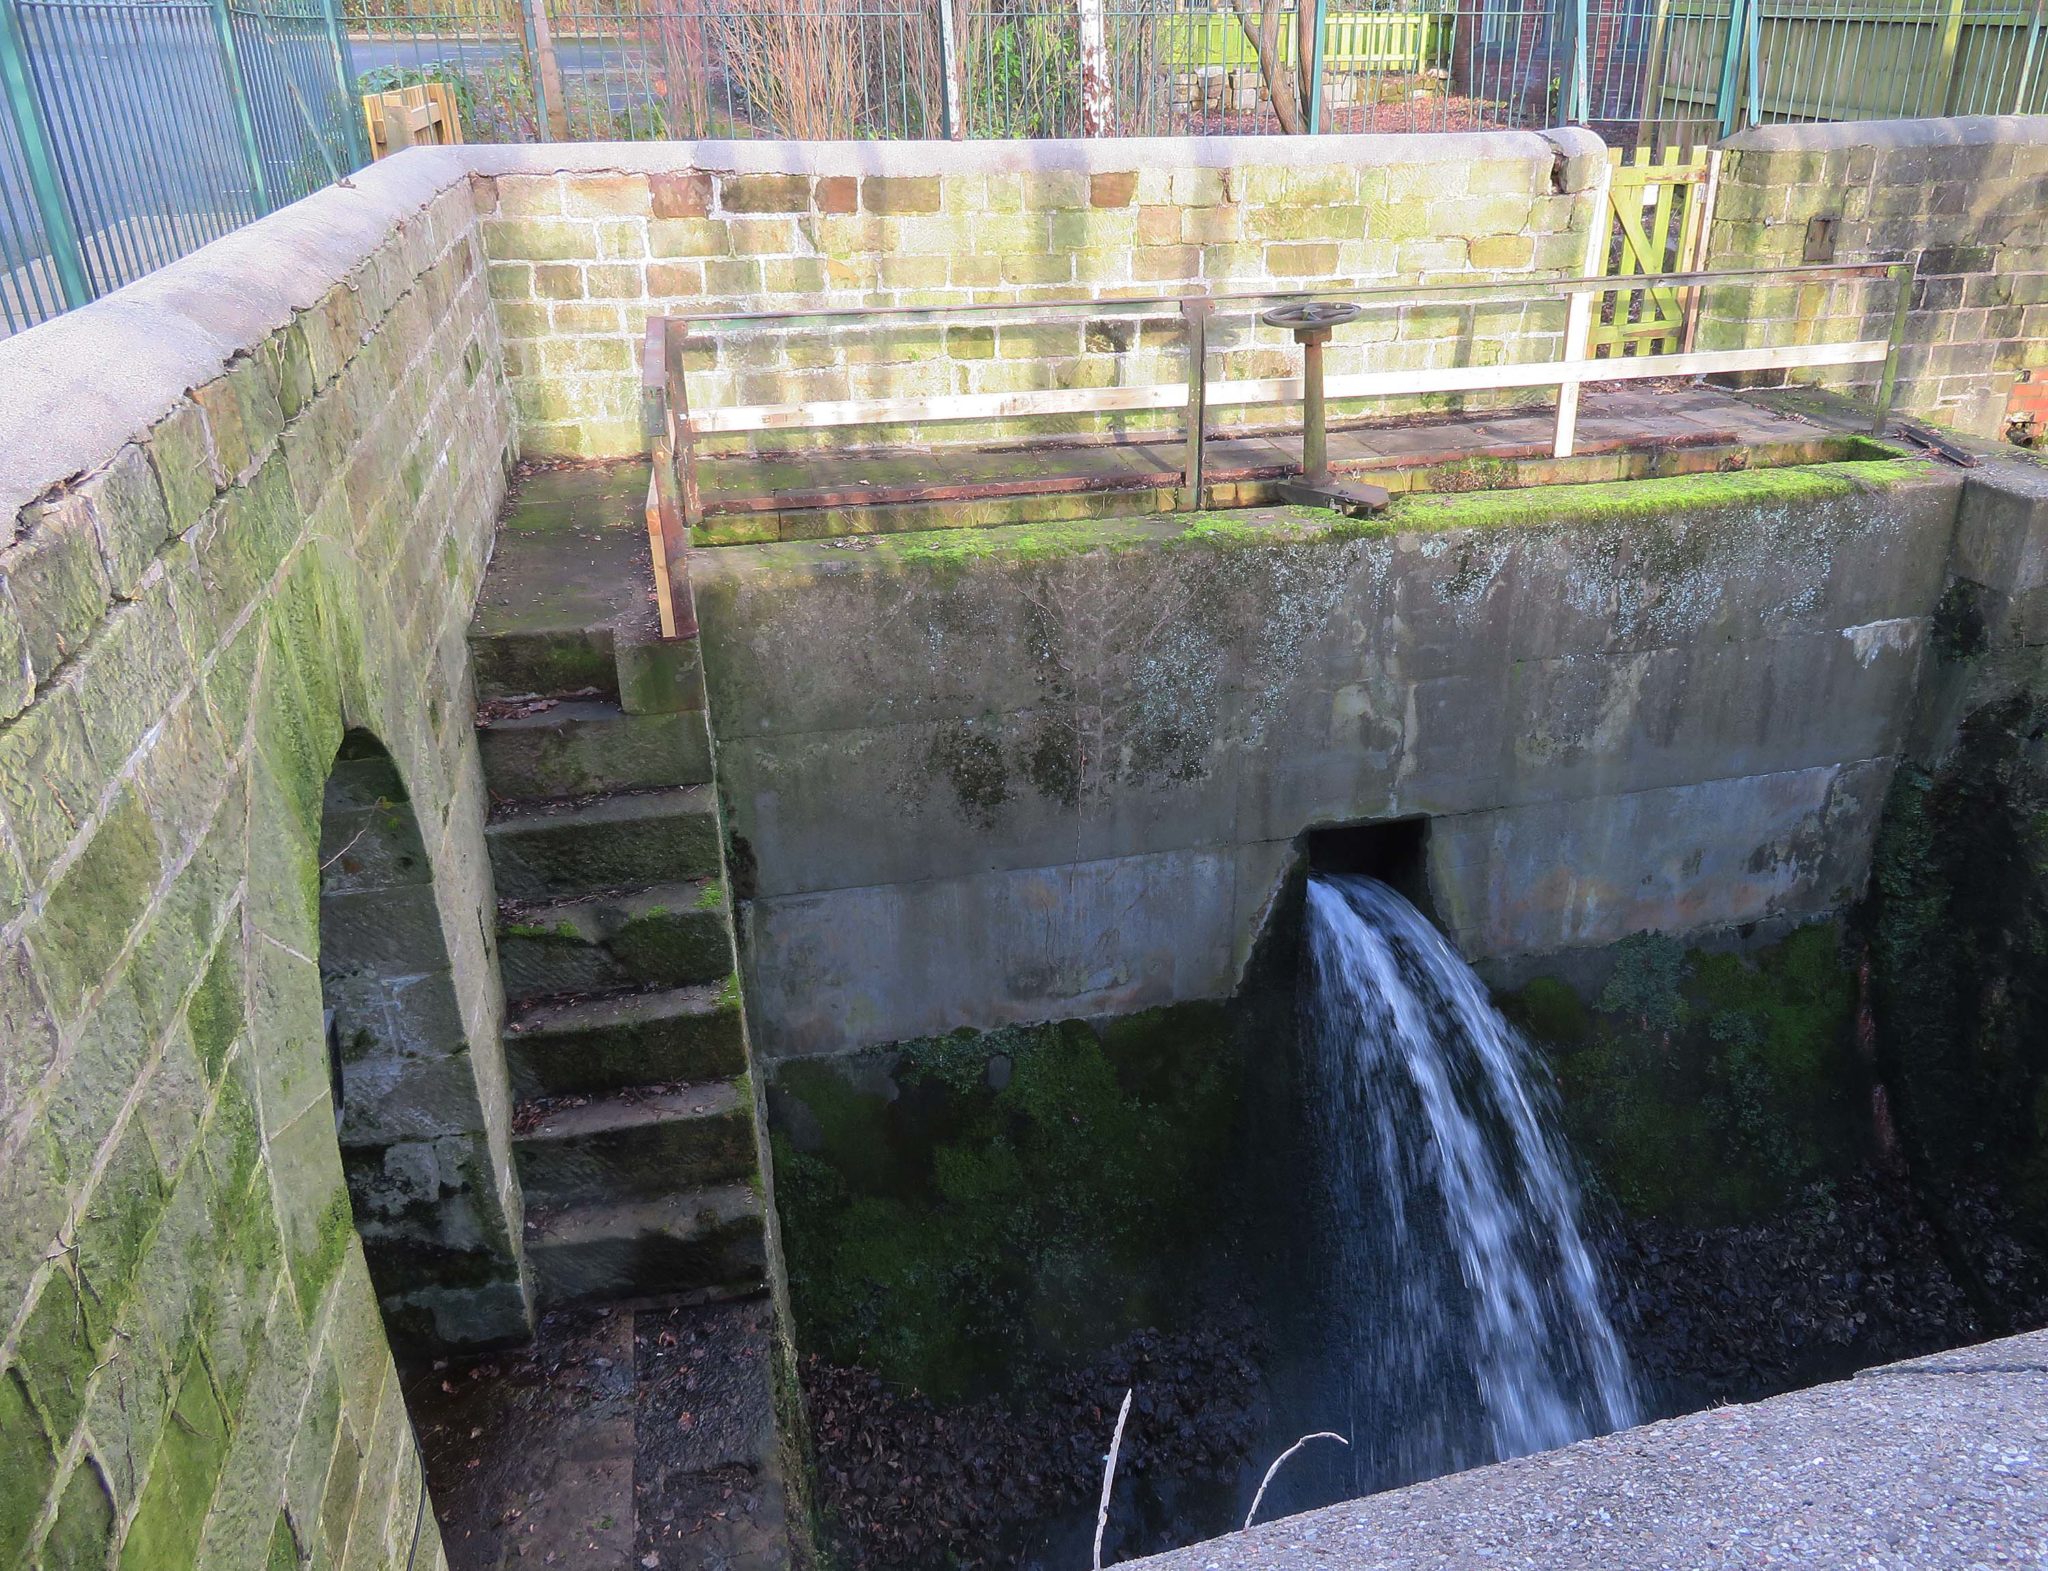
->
1700, 115, 2048, 436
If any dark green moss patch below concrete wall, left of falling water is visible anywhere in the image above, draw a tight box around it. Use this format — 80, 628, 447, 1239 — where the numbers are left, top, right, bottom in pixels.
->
774, 1006, 1237, 1399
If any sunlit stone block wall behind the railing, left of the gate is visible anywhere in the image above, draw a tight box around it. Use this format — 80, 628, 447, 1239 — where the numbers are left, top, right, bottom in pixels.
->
469, 131, 1608, 453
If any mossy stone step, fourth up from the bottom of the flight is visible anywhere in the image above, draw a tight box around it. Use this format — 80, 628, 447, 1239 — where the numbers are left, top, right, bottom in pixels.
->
498, 879, 733, 999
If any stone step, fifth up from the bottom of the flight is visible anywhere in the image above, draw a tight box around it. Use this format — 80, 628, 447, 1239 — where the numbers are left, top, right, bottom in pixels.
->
485, 784, 719, 901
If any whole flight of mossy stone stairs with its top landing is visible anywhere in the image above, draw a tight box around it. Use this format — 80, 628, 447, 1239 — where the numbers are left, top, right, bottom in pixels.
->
469, 465, 766, 1307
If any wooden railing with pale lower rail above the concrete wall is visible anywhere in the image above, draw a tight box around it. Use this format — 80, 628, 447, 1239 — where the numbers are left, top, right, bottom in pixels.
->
643, 262, 1913, 637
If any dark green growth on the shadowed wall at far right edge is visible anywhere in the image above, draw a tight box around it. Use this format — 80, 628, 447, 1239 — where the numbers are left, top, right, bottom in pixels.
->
1868, 694, 2048, 1233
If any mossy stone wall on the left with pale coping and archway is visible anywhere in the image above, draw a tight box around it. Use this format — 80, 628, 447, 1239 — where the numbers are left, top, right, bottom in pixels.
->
0, 156, 512, 1571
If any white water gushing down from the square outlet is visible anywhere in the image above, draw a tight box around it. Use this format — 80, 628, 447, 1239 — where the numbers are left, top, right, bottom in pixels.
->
1305, 877, 1638, 1489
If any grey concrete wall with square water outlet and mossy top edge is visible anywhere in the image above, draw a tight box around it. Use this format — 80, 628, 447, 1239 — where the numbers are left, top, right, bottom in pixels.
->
694, 461, 1960, 1057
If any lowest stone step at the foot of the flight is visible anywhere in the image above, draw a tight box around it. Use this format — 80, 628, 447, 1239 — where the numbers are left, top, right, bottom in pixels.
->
526, 1184, 768, 1309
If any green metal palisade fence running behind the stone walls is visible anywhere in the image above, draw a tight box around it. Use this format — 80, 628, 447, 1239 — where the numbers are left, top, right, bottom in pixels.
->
0, 0, 2048, 332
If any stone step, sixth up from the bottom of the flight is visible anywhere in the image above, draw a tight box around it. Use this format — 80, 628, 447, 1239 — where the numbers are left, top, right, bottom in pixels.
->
477, 698, 711, 801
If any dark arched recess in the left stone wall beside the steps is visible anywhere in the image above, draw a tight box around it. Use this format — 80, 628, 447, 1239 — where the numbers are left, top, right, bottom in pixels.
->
319, 729, 532, 1346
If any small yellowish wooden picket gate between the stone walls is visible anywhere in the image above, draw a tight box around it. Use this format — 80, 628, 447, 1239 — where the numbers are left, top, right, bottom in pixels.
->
1591, 147, 1720, 358
